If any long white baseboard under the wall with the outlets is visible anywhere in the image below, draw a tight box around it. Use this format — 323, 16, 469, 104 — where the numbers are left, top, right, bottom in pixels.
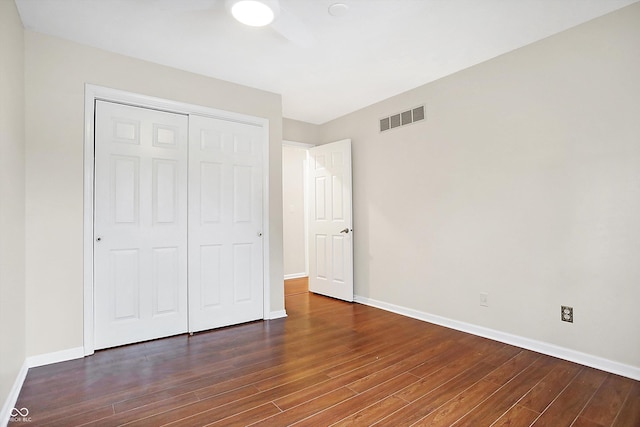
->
354, 295, 640, 381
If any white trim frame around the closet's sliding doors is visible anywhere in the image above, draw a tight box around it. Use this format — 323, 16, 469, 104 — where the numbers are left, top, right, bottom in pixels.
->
83, 84, 271, 356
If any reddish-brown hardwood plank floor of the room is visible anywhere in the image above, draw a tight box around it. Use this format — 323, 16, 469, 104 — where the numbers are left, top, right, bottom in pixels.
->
10, 282, 640, 427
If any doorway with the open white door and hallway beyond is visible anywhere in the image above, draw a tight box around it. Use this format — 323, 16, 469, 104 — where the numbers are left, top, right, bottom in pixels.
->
282, 139, 354, 301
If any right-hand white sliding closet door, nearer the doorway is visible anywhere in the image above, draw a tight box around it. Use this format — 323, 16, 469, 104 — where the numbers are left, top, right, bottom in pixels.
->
189, 115, 264, 332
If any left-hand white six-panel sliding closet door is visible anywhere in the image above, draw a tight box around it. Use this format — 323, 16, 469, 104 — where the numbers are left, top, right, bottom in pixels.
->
94, 101, 188, 349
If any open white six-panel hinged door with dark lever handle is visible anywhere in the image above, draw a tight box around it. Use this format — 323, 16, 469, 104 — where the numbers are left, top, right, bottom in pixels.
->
308, 139, 353, 301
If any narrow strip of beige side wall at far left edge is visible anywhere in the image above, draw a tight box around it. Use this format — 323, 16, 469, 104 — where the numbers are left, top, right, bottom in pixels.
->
0, 1, 26, 412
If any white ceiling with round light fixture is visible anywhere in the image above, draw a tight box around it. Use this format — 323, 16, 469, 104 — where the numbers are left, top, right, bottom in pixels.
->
16, 0, 637, 124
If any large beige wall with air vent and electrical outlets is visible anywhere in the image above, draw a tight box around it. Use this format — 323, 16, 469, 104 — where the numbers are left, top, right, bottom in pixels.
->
322, 4, 640, 368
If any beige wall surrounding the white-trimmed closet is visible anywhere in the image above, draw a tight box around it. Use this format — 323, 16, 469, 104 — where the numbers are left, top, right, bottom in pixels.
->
25, 31, 284, 356
